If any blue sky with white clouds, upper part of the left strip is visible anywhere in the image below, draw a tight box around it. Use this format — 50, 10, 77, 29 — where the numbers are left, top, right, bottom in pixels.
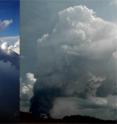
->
0, 0, 20, 54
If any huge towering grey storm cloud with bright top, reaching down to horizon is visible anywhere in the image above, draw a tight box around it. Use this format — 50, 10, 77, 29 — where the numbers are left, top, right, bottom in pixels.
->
32, 5, 117, 119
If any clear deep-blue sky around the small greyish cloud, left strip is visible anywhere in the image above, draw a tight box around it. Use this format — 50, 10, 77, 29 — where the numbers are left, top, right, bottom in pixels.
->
0, 0, 19, 37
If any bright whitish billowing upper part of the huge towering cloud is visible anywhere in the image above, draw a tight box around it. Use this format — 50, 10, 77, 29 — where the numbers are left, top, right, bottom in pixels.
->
38, 6, 117, 70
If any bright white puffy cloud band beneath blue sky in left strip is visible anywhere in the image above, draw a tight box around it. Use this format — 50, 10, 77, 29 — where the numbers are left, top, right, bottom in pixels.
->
0, 36, 20, 54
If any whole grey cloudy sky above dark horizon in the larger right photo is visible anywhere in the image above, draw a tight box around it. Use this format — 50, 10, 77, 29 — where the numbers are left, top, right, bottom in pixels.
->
20, 0, 117, 120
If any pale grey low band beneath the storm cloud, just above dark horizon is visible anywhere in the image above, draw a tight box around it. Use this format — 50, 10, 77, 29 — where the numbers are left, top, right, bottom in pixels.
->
50, 96, 117, 120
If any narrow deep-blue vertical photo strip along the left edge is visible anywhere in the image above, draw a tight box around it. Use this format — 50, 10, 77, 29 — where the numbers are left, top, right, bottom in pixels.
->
0, 0, 20, 123
